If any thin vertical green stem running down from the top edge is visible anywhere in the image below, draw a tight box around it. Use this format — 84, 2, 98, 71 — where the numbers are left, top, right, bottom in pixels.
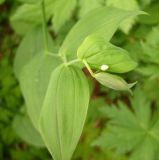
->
41, 0, 49, 51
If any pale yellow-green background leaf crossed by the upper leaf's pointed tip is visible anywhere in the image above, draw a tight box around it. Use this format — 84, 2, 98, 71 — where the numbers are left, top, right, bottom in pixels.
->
106, 0, 139, 33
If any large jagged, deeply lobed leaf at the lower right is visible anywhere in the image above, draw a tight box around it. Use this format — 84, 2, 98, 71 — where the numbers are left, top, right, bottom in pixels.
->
94, 89, 159, 160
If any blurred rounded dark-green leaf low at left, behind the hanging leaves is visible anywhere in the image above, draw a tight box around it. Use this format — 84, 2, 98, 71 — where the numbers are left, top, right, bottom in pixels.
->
13, 107, 45, 147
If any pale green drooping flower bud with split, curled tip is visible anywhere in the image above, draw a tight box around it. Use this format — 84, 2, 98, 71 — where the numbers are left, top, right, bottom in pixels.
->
94, 72, 136, 93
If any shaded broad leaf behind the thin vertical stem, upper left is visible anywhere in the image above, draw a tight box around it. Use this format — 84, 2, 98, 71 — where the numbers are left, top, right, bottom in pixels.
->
14, 26, 53, 78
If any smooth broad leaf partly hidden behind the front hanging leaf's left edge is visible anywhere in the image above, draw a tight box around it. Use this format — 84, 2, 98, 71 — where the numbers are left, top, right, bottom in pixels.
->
20, 52, 61, 129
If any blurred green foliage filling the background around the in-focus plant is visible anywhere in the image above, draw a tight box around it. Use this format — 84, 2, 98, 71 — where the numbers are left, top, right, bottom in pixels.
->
0, 0, 159, 160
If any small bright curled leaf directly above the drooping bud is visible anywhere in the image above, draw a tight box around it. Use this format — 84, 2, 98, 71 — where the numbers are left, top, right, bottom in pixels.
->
77, 34, 137, 73
